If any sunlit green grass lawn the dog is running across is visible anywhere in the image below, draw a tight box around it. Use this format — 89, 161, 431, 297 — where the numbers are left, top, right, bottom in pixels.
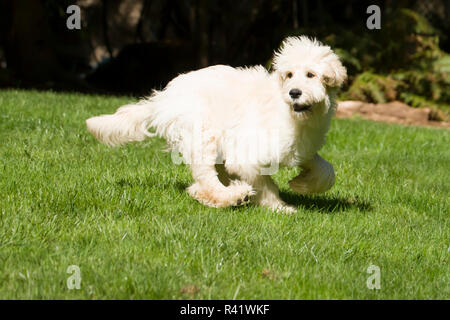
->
0, 90, 450, 299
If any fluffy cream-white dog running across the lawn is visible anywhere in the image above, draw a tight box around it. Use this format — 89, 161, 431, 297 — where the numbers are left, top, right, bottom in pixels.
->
86, 36, 347, 213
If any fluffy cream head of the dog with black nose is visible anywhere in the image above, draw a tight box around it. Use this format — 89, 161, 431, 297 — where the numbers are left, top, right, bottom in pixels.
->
273, 36, 347, 118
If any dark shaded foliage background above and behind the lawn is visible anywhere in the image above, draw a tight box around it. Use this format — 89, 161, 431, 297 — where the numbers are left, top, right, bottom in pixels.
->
0, 0, 450, 110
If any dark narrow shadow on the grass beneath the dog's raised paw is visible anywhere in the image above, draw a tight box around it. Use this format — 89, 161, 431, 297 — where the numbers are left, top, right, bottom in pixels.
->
280, 191, 372, 213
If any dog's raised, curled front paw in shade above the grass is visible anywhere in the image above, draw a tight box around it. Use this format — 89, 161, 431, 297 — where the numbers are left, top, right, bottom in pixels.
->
289, 154, 335, 194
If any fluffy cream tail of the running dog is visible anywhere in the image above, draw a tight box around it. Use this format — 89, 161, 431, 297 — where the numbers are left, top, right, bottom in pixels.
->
86, 101, 155, 146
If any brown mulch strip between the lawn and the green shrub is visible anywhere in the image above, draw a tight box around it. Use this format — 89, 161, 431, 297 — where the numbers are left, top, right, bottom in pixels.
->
336, 100, 450, 129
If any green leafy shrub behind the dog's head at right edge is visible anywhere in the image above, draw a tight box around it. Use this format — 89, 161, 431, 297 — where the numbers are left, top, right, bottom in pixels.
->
332, 9, 450, 114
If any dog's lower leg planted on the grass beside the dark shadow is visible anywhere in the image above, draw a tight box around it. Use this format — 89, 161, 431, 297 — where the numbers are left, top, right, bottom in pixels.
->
253, 175, 297, 214
